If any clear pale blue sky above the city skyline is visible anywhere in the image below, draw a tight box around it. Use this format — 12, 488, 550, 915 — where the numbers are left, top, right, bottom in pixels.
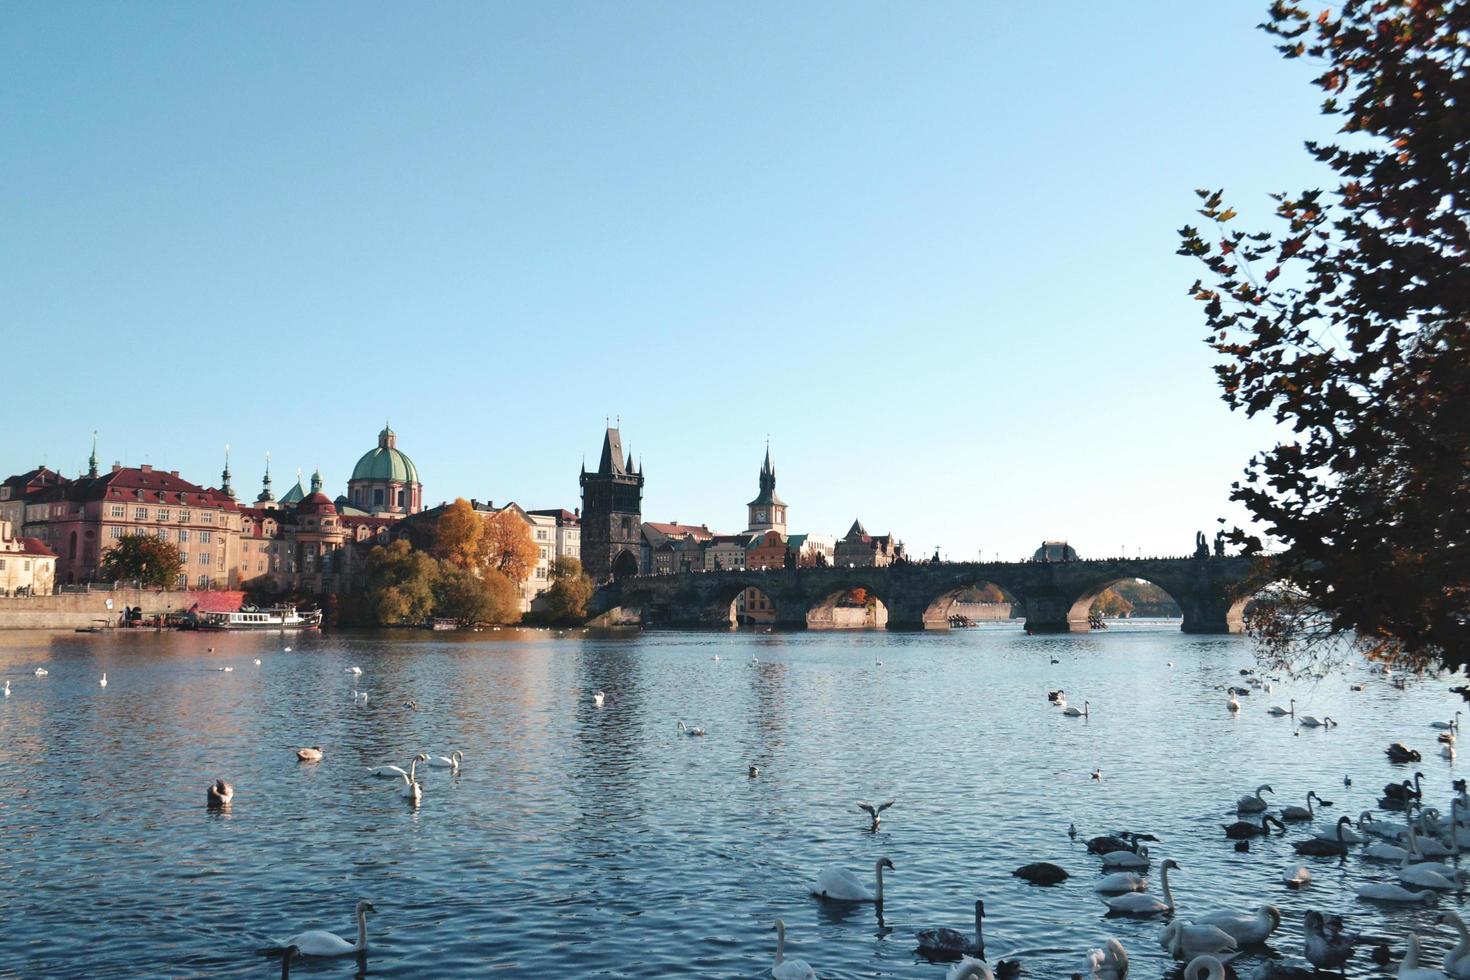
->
0, 0, 1327, 558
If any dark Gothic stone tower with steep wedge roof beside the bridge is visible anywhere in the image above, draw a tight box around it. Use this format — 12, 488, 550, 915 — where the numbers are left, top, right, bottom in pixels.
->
581, 428, 644, 582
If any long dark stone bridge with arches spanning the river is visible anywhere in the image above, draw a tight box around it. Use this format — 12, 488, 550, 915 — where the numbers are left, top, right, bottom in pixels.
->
589, 557, 1269, 633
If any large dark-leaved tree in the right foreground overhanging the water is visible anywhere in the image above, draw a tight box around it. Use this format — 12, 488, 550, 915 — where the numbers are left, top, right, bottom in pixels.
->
1179, 0, 1470, 667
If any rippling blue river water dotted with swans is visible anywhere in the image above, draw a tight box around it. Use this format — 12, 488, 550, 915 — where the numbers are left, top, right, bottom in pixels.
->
0, 623, 1466, 977
